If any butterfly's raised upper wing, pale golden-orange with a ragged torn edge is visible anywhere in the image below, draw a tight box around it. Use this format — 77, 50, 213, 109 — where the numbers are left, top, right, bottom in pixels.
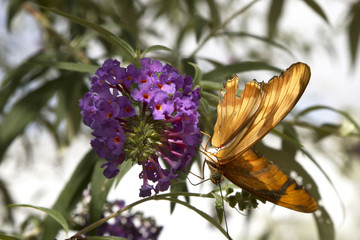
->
211, 63, 310, 164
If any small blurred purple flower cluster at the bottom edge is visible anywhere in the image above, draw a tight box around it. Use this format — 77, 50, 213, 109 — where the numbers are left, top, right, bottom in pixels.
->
97, 201, 162, 240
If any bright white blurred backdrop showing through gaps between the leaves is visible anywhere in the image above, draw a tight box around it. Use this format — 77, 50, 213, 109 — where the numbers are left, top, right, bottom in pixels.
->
0, 0, 360, 240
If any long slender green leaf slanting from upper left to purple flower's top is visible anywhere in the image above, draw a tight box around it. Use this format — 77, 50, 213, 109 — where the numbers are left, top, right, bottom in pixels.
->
39, 5, 137, 64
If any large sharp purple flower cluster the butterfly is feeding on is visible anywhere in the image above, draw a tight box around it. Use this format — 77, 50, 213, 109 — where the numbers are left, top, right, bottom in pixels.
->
79, 58, 200, 197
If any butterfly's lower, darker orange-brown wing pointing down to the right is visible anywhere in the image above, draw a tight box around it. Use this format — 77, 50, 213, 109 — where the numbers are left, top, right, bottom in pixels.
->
221, 148, 318, 213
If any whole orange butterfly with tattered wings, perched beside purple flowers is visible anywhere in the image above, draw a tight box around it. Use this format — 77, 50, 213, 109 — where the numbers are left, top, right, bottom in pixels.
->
205, 63, 318, 213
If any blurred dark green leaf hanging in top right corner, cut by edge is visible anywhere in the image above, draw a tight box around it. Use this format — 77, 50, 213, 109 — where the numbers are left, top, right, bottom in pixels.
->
348, 1, 360, 65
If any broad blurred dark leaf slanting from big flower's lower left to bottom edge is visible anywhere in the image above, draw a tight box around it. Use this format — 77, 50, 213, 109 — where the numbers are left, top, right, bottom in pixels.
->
42, 150, 100, 240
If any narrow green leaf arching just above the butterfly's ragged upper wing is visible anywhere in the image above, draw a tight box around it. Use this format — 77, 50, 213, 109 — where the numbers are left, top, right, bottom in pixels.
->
203, 62, 283, 82
